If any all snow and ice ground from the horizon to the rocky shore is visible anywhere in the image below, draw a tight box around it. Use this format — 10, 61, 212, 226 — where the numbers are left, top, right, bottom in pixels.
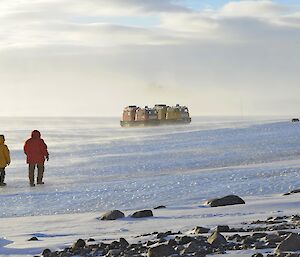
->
0, 117, 300, 257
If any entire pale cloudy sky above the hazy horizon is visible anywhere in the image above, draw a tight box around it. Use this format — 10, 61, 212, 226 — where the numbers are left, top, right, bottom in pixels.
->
0, 0, 300, 117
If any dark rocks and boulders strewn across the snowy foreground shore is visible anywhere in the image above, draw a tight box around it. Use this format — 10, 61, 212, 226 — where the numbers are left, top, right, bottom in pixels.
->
32, 194, 300, 257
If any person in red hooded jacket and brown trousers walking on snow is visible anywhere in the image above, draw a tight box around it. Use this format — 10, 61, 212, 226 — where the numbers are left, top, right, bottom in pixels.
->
24, 130, 49, 186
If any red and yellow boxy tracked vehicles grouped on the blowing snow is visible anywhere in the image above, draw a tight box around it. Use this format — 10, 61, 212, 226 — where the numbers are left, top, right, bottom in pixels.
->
120, 104, 191, 127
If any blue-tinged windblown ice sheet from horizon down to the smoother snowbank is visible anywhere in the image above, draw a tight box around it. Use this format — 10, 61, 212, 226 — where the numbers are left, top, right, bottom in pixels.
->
0, 118, 300, 217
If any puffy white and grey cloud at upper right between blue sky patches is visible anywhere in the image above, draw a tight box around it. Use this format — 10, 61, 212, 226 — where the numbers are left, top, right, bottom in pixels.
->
161, 0, 300, 44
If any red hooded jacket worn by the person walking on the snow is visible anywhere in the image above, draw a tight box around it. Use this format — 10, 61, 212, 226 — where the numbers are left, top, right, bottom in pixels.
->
24, 130, 49, 164
